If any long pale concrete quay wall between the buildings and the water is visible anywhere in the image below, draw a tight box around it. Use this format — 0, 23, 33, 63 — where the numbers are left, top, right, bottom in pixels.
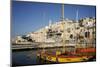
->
11, 42, 95, 50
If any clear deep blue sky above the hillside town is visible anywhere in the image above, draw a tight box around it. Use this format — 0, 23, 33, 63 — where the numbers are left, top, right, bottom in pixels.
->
11, 1, 96, 37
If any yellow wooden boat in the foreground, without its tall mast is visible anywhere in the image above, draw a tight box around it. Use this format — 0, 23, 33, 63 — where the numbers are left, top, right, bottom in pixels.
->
38, 52, 93, 63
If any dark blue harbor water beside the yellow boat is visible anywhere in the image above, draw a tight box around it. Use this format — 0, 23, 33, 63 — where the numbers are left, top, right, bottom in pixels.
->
12, 48, 95, 66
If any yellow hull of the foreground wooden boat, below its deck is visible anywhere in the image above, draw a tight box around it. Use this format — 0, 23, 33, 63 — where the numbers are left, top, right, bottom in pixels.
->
39, 54, 92, 63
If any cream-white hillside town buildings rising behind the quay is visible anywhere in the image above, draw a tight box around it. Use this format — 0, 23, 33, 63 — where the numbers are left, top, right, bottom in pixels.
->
13, 17, 96, 45
